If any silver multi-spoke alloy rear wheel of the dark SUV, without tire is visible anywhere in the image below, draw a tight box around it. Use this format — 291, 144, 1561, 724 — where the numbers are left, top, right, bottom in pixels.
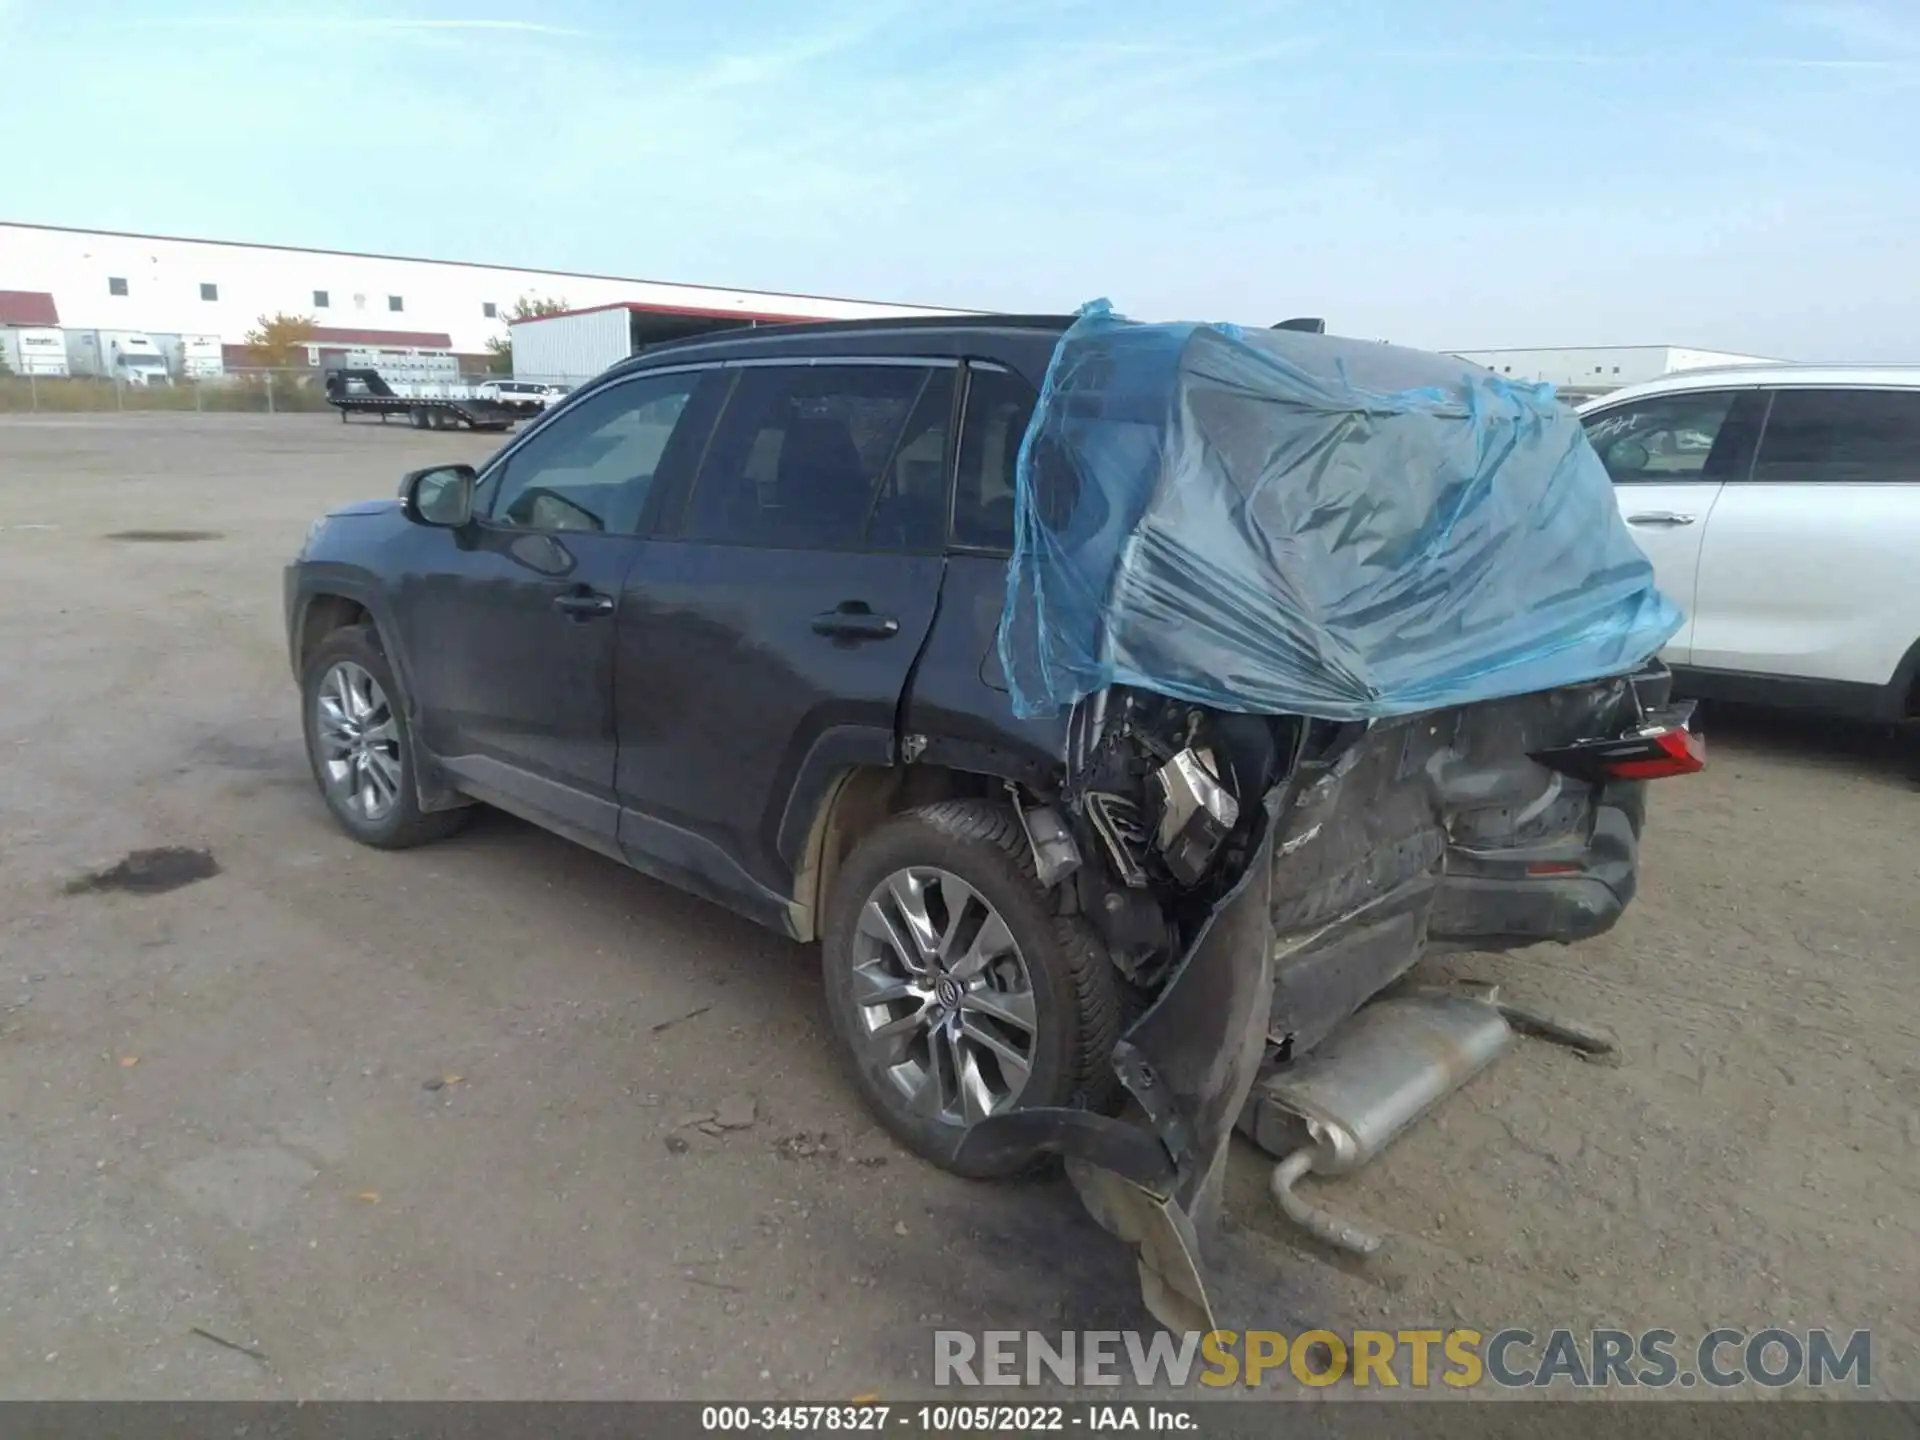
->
852, 866, 1039, 1125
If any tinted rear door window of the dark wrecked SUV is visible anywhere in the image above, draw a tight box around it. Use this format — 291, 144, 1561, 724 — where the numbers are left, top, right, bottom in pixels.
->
682, 365, 954, 551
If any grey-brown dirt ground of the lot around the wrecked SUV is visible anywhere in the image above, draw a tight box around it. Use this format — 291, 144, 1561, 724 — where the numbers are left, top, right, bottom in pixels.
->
0, 415, 1920, 1398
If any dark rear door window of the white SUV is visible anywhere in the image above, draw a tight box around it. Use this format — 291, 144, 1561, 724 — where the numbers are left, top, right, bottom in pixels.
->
1753, 390, 1920, 486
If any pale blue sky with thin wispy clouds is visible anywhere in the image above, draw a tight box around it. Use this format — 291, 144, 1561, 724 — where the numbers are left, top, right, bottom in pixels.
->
0, 0, 1920, 359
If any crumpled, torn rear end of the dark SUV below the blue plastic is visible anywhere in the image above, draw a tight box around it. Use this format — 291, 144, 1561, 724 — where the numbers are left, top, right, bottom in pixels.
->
966, 666, 1668, 1329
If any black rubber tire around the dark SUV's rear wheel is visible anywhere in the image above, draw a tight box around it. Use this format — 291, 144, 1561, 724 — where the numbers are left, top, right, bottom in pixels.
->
820, 801, 1119, 1179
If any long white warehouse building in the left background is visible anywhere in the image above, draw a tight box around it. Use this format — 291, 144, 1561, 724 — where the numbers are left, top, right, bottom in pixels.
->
0, 223, 975, 378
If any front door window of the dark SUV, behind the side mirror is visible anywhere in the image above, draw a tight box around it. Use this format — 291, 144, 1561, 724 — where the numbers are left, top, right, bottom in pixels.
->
488, 374, 701, 536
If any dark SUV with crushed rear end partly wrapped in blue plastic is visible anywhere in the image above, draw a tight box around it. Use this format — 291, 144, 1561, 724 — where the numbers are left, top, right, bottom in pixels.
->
286, 317, 1699, 1323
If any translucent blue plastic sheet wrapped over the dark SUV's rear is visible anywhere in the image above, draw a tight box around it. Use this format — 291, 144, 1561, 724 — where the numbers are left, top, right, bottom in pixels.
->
998, 301, 1680, 733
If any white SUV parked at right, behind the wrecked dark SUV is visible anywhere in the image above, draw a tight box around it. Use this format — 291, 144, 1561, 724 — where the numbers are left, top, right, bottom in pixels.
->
1580, 365, 1920, 720
